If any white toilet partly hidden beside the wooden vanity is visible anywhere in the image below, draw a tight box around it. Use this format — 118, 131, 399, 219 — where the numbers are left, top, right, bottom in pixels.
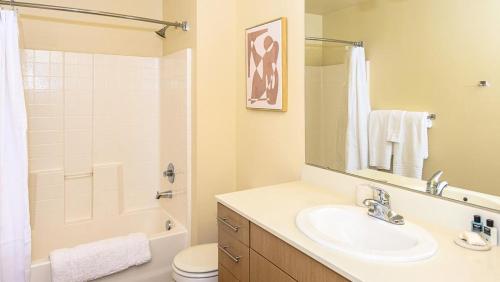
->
172, 243, 219, 282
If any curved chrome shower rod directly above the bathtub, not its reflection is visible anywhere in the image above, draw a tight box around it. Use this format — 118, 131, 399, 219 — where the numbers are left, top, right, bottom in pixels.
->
0, 0, 189, 38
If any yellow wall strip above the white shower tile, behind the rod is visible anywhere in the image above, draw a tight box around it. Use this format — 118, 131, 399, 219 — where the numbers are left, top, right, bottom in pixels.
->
19, 0, 164, 56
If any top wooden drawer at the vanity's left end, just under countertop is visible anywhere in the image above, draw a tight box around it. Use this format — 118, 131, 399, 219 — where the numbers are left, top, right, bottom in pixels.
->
217, 204, 250, 246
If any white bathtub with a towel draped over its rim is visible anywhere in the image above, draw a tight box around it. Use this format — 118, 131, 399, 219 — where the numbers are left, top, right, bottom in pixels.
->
31, 208, 189, 282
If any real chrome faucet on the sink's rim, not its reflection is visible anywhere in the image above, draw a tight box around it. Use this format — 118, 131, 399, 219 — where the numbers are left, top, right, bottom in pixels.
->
363, 188, 405, 225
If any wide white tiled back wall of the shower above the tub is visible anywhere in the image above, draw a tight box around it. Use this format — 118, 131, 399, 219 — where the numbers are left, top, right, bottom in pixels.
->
23, 50, 160, 230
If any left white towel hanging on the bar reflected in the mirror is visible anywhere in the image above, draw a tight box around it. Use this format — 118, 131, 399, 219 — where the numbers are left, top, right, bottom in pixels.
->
368, 110, 392, 170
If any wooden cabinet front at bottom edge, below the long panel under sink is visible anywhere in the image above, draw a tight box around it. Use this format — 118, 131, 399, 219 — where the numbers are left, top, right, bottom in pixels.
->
250, 249, 295, 282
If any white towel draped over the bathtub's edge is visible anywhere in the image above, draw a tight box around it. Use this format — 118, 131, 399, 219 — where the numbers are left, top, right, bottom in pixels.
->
50, 233, 151, 282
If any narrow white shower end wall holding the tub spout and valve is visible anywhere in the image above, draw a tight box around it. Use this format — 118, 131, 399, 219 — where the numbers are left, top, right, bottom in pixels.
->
160, 49, 191, 229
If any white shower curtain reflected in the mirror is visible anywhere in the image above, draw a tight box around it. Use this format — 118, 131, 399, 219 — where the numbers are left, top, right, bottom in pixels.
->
345, 47, 371, 171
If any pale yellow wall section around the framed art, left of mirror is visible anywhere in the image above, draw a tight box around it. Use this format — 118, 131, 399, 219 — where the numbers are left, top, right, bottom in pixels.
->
235, 0, 305, 189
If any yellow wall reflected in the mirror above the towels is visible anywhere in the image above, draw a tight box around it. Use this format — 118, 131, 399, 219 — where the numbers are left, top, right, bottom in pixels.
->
323, 0, 500, 195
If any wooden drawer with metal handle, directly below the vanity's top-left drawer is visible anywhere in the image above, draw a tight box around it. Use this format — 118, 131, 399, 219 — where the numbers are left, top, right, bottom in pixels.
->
219, 226, 250, 282
